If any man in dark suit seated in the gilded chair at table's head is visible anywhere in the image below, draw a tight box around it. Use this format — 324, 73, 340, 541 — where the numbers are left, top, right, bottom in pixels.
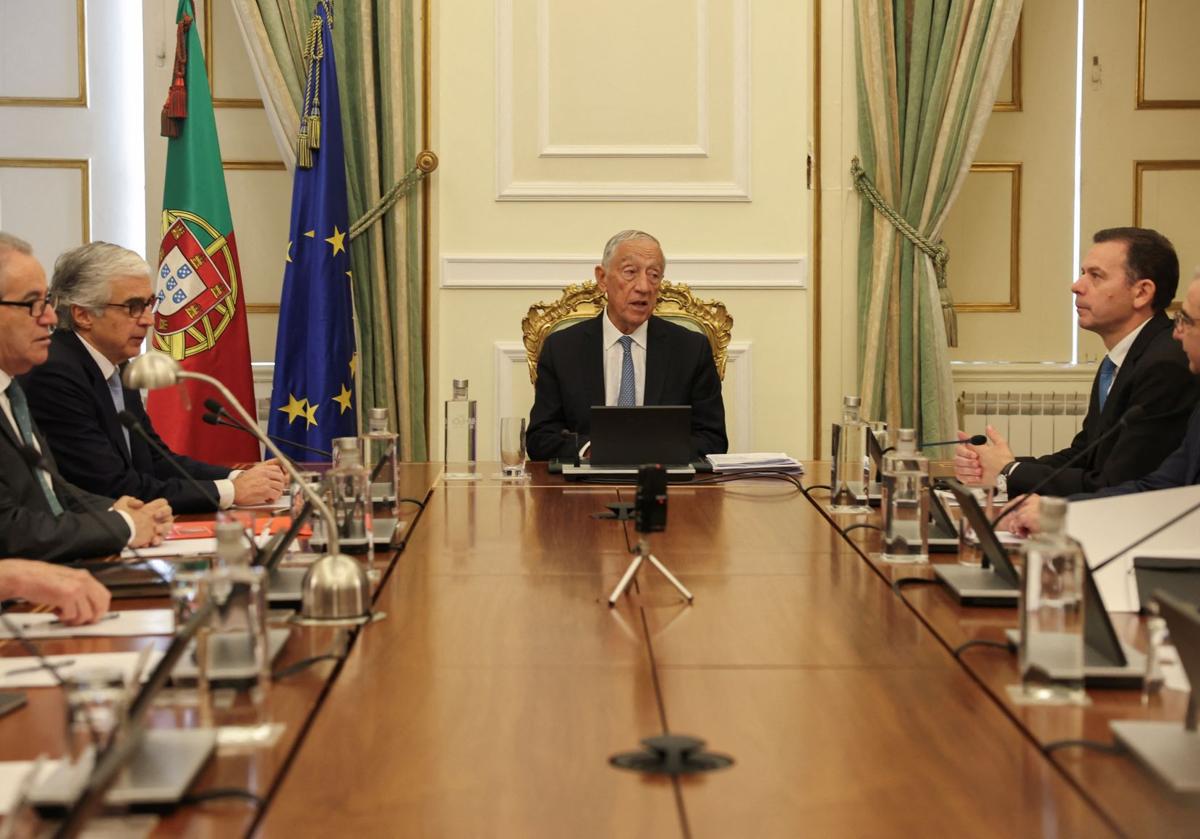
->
526, 230, 728, 460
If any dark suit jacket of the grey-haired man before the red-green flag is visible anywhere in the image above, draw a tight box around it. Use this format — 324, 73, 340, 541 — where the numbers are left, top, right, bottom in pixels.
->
22, 330, 229, 513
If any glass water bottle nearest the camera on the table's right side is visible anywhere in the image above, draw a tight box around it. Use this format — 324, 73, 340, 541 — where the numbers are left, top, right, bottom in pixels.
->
1014, 498, 1087, 705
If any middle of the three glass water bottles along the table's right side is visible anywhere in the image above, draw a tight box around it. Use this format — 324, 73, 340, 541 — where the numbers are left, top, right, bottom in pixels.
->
872, 429, 929, 563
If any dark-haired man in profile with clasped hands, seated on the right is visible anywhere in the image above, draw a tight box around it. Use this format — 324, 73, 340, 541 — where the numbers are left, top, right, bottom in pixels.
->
954, 227, 1200, 496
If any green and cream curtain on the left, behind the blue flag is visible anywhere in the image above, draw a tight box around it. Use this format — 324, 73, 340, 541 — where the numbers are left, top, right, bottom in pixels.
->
234, 0, 428, 460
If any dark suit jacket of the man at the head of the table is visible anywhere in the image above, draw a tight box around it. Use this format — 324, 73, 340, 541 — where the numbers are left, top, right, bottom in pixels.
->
526, 312, 728, 460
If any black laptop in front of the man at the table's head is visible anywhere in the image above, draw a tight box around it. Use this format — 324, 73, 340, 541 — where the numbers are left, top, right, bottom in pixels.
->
562, 404, 696, 480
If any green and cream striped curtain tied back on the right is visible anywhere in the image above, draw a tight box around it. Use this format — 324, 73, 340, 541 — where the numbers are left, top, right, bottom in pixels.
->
854, 0, 1022, 439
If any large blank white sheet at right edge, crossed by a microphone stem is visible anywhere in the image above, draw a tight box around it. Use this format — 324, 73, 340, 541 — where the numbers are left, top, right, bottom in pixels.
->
1067, 486, 1200, 612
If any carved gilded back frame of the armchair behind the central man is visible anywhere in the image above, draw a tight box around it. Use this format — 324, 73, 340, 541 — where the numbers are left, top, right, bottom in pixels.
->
521, 280, 733, 384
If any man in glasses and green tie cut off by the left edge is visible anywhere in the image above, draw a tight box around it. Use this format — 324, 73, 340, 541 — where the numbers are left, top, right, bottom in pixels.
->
0, 233, 172, 561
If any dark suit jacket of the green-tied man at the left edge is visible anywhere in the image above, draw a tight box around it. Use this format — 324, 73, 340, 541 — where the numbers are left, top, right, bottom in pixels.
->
0, 391, 130, 562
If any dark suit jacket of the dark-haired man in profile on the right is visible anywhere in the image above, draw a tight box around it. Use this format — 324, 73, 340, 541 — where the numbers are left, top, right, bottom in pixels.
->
1008, 312, 1200, 496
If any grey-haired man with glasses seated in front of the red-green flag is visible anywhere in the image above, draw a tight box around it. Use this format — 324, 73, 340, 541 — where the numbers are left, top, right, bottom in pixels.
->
23, 241, 286, 513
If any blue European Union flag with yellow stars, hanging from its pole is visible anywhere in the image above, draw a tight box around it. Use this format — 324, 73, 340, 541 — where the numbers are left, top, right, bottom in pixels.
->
269, 2, 358, 461
